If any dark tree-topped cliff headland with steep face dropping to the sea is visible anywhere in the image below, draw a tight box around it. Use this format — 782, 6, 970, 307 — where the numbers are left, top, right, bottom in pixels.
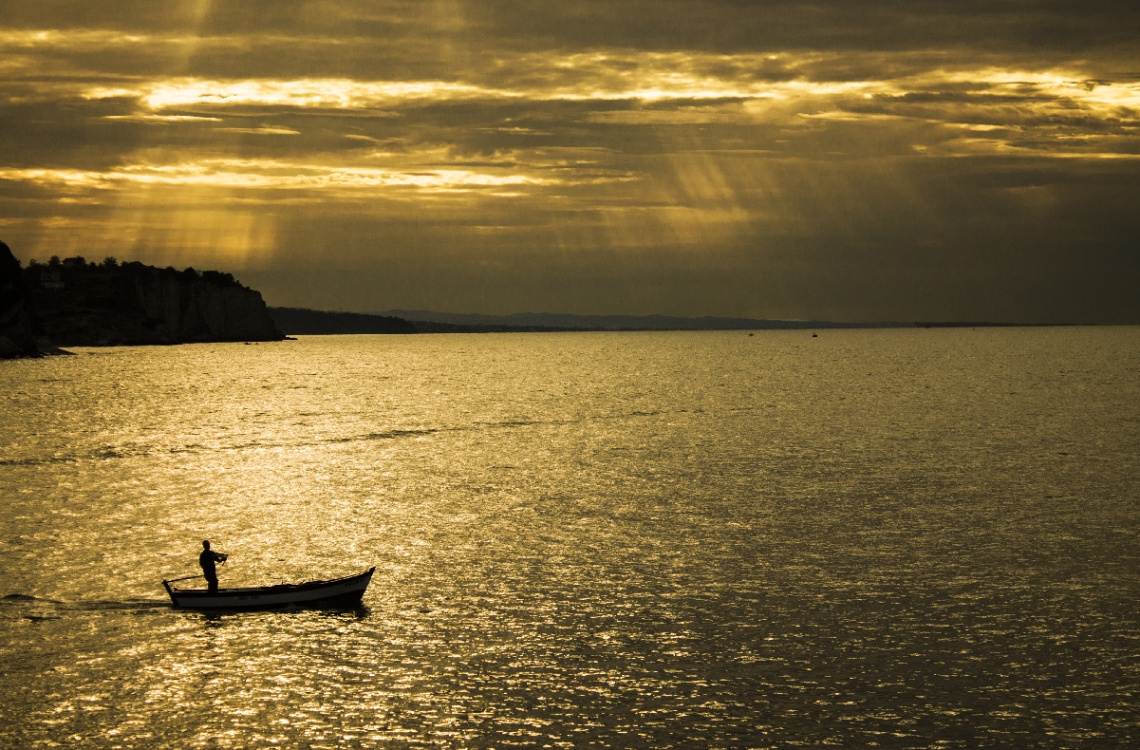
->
24, 259, 285, 347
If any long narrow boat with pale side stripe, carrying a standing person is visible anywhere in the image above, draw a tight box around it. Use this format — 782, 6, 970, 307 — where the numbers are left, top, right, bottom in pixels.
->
162, 568, 376, 610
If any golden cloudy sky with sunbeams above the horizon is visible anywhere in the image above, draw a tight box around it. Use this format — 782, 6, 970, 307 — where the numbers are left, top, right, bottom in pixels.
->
0, 0, 1140, 324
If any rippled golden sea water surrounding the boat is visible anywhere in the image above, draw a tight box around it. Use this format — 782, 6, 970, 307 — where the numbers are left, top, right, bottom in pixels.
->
0, 327, 1140, 748
